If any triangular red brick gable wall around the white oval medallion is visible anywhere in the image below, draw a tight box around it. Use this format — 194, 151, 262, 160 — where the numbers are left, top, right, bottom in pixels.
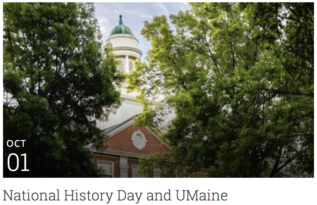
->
105, 125, 169, 154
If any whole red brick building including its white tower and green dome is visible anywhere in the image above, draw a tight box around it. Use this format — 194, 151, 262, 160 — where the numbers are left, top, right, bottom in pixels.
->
90, 15, 169, 177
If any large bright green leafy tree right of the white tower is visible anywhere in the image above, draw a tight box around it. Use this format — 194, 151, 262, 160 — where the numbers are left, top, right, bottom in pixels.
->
128, 3, 314, 177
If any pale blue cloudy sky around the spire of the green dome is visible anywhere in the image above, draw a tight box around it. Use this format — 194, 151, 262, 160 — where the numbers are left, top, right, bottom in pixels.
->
95, 2, 191, 60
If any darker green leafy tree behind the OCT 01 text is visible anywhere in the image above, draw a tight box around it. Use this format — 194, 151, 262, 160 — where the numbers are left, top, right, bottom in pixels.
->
3, 3, 123, 177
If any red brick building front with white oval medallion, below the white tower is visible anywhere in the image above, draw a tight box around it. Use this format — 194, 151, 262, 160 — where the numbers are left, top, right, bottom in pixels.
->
91, 117, 169, 177
